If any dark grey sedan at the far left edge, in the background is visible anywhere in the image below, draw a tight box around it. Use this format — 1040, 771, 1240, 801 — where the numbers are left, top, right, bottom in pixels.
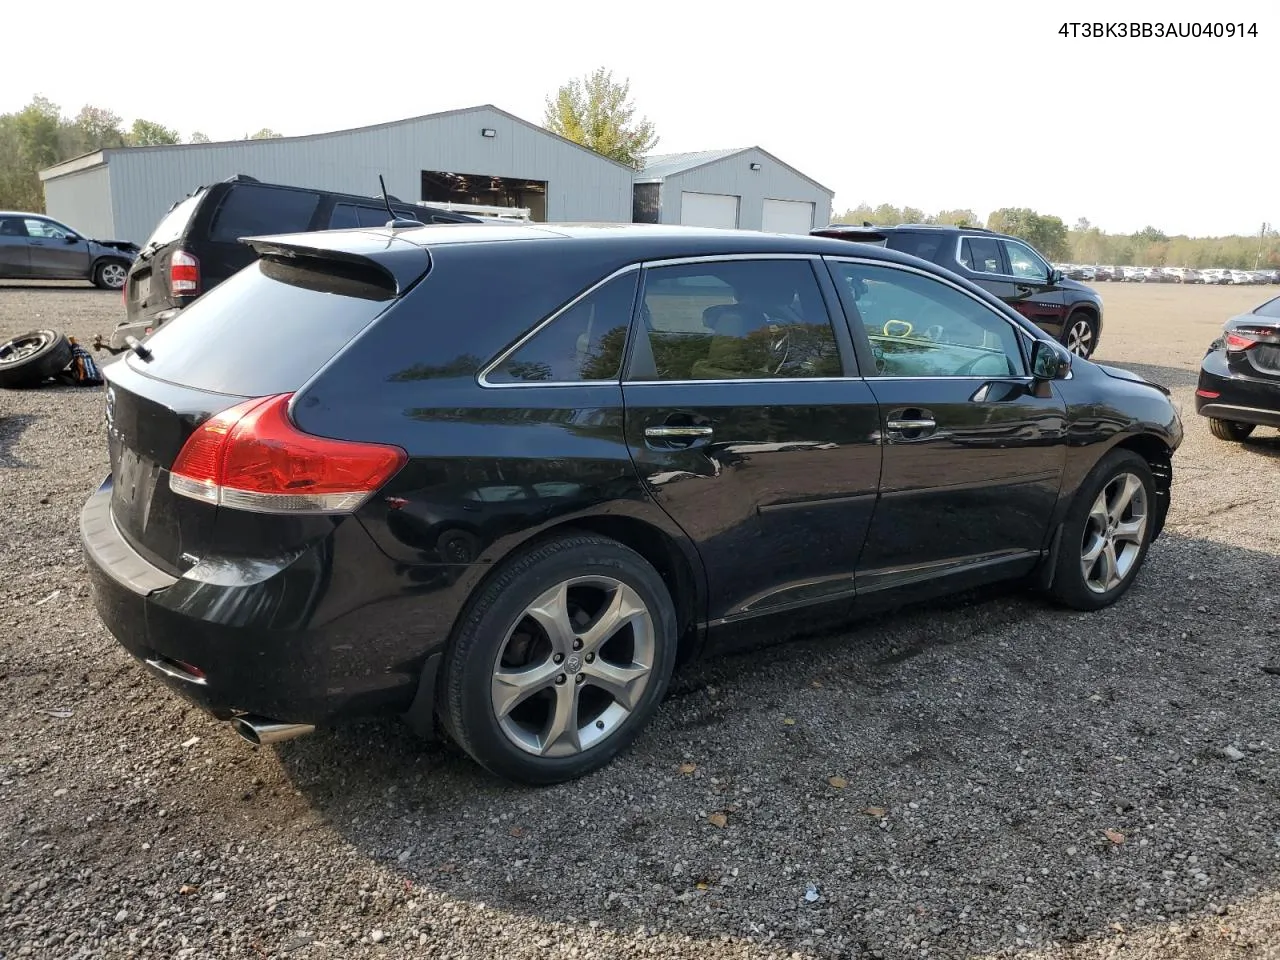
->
0, 211, 138, 291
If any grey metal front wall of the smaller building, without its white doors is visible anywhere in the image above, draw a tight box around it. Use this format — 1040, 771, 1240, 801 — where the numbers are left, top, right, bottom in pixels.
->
662, 150, 832, 230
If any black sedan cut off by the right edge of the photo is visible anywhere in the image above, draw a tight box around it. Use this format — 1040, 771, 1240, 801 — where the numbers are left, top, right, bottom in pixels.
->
1196, 297, 1280, 443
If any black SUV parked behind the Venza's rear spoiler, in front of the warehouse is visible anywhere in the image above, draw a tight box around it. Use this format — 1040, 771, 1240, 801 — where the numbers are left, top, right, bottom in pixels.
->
93, 174, 483, 353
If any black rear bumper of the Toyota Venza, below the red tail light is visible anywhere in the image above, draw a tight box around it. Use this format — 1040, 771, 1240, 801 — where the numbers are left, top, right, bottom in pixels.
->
81, 480, 443, 724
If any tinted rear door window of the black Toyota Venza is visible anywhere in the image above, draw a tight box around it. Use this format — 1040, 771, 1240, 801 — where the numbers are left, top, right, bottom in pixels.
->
631, 260, 844, 380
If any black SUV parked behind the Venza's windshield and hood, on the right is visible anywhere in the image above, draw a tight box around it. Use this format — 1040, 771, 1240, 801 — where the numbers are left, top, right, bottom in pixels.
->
813, 224, 1102, 358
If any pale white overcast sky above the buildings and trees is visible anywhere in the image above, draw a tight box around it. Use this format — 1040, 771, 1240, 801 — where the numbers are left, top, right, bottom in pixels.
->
0, 0, 1280, 236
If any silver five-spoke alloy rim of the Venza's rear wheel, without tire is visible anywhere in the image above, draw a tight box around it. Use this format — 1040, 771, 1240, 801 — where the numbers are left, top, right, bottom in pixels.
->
490, 576, 657, 756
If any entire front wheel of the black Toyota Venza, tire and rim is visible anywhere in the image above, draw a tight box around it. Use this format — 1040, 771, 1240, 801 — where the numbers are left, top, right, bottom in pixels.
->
1048, 451, 1157, 611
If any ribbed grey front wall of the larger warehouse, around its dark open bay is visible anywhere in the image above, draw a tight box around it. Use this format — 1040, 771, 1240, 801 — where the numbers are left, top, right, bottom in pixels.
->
97, 109, 632, 243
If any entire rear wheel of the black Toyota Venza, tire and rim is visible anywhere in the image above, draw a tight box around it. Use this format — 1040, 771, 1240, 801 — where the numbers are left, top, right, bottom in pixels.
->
440, 534, 678, 785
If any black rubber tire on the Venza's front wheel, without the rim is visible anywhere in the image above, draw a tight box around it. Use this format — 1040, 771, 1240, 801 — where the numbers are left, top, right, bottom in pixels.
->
1048, 449, 1157, 611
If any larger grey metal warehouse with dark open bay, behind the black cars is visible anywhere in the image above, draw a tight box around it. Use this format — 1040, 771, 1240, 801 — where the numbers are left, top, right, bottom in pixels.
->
40, 105, 635, 243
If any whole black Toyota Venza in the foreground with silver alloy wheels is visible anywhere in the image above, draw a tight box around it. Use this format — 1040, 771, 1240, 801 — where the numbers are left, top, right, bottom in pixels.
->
82, 225, 1183, 783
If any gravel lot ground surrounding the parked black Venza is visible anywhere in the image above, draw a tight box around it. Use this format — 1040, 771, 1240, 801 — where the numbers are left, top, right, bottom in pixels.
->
0, 285, 1280, 960
